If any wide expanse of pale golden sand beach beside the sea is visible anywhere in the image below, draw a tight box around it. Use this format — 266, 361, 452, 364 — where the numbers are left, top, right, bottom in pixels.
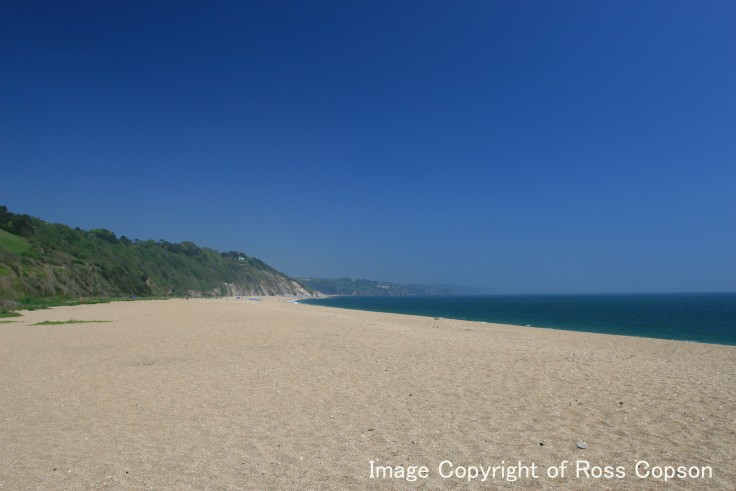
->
0, 298, 736, 490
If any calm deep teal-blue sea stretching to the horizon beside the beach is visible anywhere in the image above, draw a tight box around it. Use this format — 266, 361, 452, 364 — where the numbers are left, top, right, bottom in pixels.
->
304, 293, 736, 345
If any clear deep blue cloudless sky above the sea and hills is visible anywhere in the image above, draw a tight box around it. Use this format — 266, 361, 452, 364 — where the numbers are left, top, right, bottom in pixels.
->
0, 0, 736, 293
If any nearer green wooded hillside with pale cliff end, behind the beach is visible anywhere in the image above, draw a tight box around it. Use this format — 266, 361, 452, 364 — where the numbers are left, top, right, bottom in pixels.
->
0, 206, 309, 308
